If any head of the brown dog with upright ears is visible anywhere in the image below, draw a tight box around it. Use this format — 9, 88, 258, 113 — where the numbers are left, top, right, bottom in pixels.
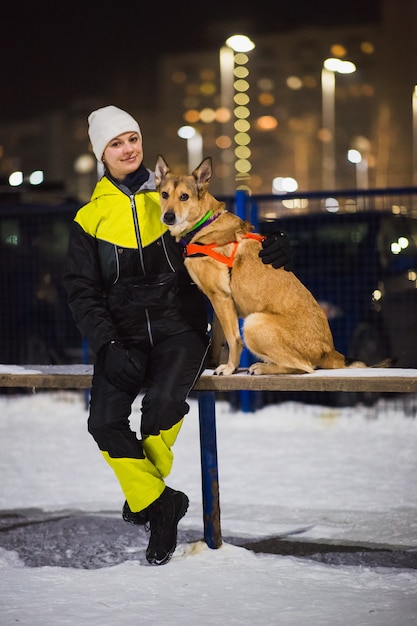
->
155, 156, 211, 237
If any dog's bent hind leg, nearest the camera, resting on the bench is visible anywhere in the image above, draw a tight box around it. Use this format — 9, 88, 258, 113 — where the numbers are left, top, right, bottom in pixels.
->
243, 313, 314, 374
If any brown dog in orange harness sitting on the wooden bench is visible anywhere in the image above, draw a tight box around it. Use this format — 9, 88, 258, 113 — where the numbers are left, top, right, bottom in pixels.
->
155, 156, 366, 375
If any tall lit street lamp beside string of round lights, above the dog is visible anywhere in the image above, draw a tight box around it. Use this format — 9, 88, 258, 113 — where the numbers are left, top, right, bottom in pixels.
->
220, 35, 255, 193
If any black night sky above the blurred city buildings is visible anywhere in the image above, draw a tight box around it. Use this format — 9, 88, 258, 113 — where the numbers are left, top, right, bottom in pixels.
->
0, 0, 381, 124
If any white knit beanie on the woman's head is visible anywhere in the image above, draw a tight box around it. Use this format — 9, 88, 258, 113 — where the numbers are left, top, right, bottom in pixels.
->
88, 104, 142, 161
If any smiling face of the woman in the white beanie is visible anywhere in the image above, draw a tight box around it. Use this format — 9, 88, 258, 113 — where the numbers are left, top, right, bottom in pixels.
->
103, 132, 143, 180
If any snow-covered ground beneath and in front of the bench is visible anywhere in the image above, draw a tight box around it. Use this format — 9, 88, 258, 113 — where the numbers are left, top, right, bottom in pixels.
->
0, 392, 417, 626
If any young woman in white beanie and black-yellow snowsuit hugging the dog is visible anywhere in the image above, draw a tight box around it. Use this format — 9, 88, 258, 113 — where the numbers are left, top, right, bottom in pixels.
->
64, 105, 290, 565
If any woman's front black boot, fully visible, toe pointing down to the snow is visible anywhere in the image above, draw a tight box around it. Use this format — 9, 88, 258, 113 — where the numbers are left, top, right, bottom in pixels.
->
146, 487, 189, 565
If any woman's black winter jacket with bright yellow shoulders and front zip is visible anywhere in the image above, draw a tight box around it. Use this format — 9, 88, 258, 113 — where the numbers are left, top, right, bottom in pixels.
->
64, 172, 207, 354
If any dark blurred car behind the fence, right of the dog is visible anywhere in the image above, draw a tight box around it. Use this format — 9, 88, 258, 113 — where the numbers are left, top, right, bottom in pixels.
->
260, 211, 417, 404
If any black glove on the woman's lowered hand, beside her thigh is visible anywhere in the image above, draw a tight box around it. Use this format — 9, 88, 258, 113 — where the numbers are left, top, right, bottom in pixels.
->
103, 340, 143, 393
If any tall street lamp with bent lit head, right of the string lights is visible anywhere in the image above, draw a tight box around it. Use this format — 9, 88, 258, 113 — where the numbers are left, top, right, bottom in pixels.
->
321, 58, 356, 190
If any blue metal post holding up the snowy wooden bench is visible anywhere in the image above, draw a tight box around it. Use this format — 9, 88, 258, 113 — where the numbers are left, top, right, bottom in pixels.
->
198, 391, 222, 548
